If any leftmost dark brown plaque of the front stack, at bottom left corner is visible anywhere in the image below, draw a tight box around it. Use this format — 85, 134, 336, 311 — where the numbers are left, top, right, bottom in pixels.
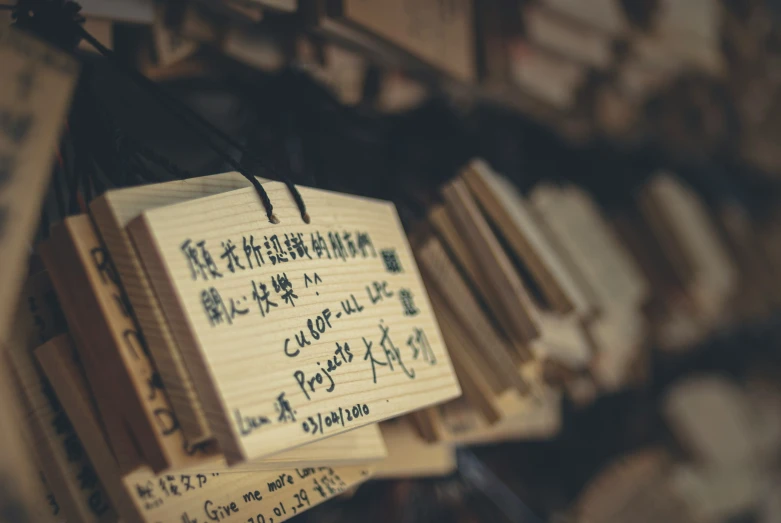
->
7, 290, 117, 522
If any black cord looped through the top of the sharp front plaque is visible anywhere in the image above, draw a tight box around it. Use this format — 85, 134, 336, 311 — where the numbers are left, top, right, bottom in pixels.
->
78, 26, 309, 223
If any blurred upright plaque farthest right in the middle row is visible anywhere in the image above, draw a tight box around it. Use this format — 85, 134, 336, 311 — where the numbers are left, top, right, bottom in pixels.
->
644, 174, 738, 317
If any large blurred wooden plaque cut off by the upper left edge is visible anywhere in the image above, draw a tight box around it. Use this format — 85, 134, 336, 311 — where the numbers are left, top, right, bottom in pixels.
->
0, 27, 78, 339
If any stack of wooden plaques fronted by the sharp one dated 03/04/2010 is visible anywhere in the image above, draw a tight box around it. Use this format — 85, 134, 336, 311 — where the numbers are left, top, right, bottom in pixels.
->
7, 166, 476, 521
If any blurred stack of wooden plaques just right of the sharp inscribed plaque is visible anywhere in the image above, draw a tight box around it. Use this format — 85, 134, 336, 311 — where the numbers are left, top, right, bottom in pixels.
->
406, 161, 648, 450
